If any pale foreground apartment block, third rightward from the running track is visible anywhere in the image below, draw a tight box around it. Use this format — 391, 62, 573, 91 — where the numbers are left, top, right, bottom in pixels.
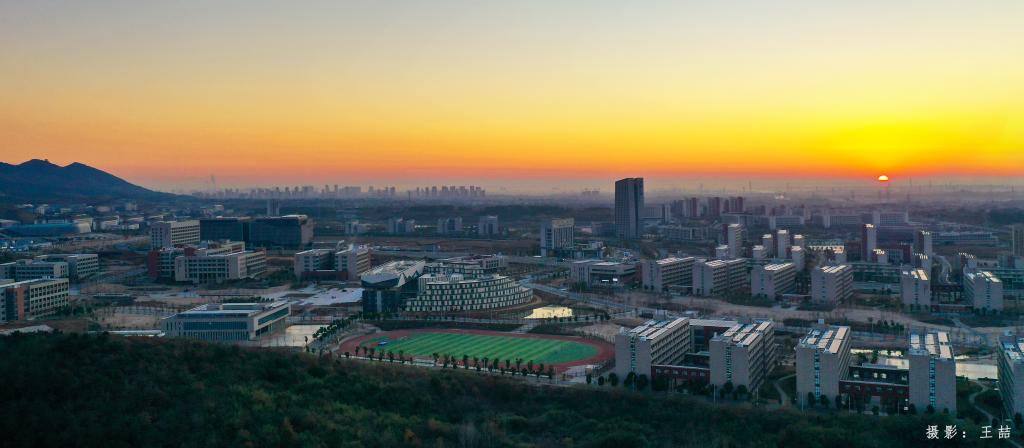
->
797, 326, 852, 405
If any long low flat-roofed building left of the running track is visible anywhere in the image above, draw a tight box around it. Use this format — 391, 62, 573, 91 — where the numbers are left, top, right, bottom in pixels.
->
162, 302, 291, 343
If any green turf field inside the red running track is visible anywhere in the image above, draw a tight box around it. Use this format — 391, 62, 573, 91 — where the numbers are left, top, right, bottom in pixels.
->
360, 331, 599, 364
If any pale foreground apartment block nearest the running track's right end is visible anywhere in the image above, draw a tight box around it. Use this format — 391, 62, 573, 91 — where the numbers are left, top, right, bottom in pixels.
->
615, 317, 692, 378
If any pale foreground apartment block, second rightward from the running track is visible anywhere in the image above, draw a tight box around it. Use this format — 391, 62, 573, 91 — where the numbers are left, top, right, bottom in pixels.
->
710, 320, 775, 394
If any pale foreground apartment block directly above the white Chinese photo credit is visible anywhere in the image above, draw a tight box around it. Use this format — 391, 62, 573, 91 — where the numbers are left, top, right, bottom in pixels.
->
906, 331, 956, 413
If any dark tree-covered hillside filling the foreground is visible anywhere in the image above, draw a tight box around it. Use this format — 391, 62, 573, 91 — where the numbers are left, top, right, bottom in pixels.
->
0, 334, 983, 448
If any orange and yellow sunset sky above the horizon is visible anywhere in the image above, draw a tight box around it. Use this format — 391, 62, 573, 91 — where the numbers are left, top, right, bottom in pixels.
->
0, 0, 1024, 188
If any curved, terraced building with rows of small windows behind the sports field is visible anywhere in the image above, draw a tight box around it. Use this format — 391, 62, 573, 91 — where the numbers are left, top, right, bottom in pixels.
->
404, 274, 534, 313
